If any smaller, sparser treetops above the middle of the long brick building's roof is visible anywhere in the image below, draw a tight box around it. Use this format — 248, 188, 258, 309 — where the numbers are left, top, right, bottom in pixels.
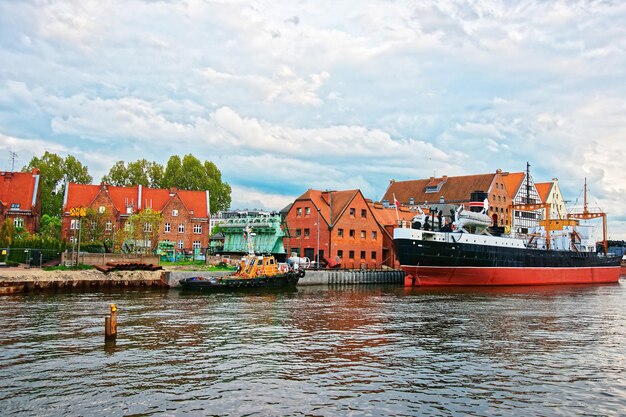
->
102, 159, 163, 188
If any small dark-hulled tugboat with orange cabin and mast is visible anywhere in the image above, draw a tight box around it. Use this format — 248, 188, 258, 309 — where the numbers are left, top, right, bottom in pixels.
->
179, 226, 305, 292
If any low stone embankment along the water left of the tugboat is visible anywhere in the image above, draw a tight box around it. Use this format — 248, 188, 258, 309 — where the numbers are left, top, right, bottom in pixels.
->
0, 267, 167, 292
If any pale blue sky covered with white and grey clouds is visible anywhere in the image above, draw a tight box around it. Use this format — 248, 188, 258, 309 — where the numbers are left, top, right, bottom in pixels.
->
0, 0, 626, 239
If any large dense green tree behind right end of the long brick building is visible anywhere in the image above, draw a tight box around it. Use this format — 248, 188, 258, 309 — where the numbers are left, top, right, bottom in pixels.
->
163, 154, 231, 212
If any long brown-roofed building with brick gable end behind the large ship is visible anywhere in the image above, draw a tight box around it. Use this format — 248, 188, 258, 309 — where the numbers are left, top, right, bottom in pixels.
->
382, 169, 511, 226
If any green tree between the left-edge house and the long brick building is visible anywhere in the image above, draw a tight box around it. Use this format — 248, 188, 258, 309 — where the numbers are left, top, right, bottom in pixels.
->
22, 151, 92, 218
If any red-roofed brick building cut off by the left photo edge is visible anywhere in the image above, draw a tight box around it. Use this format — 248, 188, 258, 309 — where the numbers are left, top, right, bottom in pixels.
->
0, 168, 41, 234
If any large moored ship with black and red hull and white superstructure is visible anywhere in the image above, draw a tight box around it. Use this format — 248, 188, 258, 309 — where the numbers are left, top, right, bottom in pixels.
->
394, 180, 622, 286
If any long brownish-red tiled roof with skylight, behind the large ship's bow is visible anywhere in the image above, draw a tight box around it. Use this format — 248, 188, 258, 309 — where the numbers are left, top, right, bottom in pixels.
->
383, 173, 496, 204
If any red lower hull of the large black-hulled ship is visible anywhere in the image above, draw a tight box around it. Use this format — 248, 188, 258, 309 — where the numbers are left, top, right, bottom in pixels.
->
402, 265, 620, 287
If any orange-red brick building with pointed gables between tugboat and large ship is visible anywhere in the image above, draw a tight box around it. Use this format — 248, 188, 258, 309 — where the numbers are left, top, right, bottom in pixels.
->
285, 190, 413, 268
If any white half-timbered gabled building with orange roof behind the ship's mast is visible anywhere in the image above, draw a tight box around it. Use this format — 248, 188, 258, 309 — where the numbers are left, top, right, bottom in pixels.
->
502, 172, 543, 234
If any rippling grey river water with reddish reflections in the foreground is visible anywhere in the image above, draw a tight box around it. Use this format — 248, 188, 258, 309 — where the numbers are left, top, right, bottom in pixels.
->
0, 282, 626, 417
